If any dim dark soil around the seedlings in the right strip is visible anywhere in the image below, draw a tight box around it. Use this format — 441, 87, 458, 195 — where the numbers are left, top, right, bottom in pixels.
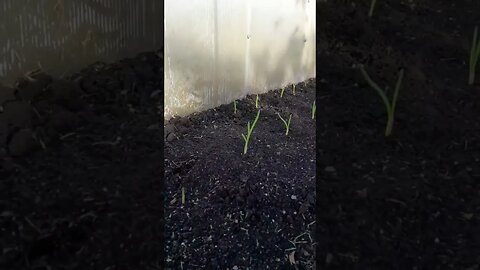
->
316, 0, 480, 270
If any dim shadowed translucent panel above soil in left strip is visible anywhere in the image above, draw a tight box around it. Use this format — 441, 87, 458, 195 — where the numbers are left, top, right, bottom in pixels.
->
0, 0, 164, 84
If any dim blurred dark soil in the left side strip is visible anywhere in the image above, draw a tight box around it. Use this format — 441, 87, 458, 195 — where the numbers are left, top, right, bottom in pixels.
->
0, 52, 163, 269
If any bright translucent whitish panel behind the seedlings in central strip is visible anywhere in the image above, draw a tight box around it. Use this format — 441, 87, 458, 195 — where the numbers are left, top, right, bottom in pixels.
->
164, 0, 315, 119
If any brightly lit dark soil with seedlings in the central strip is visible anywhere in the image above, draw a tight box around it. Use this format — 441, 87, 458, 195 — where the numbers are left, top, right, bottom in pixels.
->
165, 80, 316, 269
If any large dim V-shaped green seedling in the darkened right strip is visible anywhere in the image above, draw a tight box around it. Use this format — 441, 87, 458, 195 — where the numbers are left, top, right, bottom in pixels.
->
360, 66, 404, 137
